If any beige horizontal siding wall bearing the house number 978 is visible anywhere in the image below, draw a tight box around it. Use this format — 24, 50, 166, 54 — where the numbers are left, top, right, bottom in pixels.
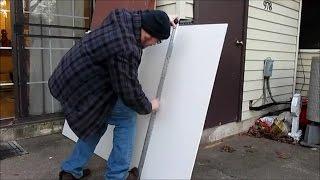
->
242, 0, 300, 120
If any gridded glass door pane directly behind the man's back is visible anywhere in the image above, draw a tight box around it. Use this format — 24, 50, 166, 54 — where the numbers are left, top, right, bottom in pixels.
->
19, 0, 90, 115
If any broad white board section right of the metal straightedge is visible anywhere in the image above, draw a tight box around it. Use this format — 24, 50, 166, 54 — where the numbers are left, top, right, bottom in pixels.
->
140, 24, 227, 179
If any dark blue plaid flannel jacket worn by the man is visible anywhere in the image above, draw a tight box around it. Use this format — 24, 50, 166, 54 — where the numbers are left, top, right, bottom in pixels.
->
49, 10, 151, 139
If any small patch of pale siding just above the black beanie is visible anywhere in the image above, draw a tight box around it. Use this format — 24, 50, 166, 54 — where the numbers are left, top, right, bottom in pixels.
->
156, 0, 193, 19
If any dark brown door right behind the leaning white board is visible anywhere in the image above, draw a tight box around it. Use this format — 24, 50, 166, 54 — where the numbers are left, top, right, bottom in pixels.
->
194, 0, 248, 128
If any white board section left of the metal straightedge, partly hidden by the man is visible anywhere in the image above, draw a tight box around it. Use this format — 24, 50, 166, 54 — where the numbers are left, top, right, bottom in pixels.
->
62, 40, 169, 167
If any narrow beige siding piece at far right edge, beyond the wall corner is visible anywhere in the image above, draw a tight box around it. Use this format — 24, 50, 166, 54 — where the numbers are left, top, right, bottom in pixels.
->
296, 49, 320, 96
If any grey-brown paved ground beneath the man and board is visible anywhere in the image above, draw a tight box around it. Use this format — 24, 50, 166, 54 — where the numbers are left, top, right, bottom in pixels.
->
0, 134, 320, 180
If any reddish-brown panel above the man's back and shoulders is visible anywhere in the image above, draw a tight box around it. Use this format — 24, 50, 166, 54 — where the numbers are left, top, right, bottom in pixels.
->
91, 0, 155, 29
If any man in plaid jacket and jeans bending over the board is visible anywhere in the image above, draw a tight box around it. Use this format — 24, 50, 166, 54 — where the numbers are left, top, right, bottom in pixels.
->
49, 10, 173, 180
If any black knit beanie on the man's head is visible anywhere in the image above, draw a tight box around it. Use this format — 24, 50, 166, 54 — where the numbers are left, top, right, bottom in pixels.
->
141, 10, 170, 40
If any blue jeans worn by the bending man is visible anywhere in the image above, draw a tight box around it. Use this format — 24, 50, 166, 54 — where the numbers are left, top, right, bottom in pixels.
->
61, 100, 137, 180
